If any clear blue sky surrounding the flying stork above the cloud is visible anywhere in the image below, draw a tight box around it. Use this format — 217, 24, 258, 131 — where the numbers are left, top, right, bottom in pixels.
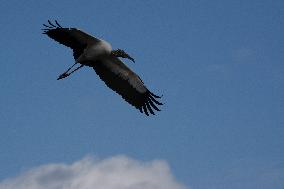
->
0, 0, 284, 189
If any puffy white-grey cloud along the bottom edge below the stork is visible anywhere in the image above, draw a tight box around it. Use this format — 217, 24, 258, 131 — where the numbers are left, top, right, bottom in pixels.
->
0, 156, 185, 189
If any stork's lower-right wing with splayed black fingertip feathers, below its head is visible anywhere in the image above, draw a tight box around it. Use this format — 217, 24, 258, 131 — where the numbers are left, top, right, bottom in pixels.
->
94, 56, 162, 116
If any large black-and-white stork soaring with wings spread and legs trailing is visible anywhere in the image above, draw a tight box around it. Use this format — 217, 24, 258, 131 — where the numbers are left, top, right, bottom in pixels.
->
42, 20, 162, 116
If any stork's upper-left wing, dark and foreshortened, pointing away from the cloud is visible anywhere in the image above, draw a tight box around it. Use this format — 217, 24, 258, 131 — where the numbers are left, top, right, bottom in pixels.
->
42, 20, 100, 60
